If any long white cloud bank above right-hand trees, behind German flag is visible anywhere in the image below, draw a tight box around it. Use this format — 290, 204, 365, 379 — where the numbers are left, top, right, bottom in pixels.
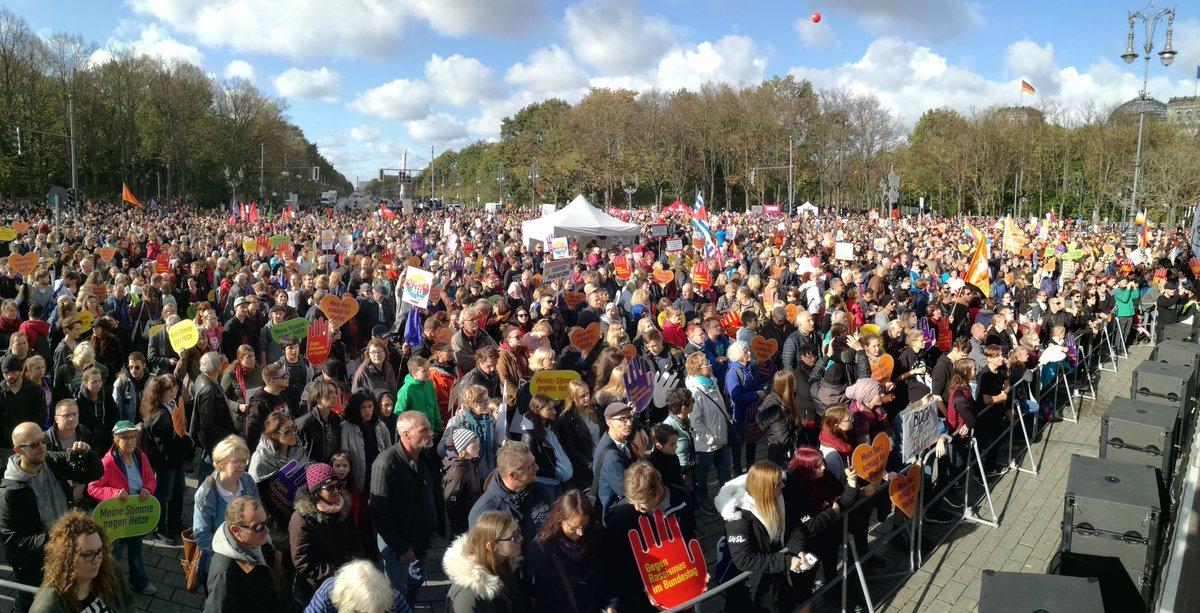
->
790, 37, 1192, 127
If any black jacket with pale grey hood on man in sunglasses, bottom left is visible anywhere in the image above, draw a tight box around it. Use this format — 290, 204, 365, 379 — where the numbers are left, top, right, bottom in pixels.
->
204, 522, 290, 613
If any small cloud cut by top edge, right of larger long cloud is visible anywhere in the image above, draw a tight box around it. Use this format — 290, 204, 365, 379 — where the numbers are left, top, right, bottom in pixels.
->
408, 0, 545, 36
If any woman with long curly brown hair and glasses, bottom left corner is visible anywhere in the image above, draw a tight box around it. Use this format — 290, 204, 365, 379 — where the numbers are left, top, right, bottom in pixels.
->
32, 510, 133, 613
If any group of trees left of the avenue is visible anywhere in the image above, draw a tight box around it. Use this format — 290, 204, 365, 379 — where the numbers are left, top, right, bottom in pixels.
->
0, 8, 350, 204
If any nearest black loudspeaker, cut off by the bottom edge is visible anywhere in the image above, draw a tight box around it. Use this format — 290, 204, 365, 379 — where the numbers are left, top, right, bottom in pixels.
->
979, 570, 1104, 613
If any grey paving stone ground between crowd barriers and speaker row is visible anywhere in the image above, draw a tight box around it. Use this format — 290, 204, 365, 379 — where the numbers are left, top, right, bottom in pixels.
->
0, 345, 1150, 613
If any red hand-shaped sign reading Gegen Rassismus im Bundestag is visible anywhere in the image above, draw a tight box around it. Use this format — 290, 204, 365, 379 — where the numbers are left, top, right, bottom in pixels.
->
629, 509, 708, 609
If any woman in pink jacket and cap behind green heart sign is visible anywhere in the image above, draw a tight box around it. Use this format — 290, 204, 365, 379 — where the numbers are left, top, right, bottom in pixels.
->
88, 420, 158, 595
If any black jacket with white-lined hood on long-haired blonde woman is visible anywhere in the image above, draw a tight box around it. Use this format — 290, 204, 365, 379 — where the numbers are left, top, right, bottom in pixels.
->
714, 475, 794, 611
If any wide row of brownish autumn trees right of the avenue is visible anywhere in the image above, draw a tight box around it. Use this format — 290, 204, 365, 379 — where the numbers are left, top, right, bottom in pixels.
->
386, 77, 1200, 220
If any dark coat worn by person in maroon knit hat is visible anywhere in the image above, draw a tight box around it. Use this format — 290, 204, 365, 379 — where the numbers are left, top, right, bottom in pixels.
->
288, 487, 366, 600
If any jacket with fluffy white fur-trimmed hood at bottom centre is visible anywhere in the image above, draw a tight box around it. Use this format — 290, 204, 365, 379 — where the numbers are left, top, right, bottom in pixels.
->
442, 535, 524, 613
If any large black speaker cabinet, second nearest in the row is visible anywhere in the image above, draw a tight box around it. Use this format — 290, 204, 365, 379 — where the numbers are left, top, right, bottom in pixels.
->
1061, 455, 1163, 602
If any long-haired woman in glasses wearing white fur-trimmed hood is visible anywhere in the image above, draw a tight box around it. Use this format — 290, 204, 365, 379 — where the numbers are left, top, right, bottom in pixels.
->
442, 511, 529, 613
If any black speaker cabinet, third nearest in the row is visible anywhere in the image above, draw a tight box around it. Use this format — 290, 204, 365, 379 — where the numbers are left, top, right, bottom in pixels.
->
1100, 396, 1178, 482
